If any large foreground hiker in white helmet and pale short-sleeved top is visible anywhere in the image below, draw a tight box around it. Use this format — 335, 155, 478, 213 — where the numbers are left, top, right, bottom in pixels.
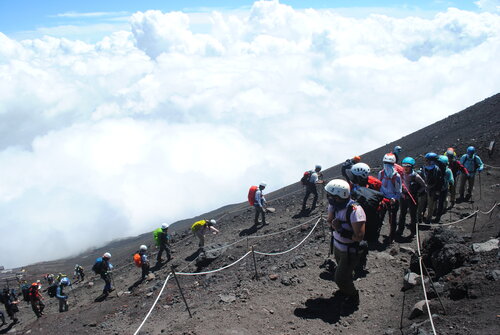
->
325, 179, 366, 306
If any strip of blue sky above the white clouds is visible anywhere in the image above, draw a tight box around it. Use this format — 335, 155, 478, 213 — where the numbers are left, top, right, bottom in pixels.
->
0, 0, 478, 42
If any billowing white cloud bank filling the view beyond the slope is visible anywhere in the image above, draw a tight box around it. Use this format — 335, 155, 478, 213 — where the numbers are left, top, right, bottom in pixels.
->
0, 1, 500, 266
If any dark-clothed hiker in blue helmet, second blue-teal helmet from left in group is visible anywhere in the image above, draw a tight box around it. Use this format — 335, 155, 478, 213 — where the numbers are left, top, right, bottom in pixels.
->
417, 152, 444, 224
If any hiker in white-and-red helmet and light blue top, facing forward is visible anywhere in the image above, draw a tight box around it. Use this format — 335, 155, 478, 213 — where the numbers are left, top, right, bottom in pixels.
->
378, 153, 402, 243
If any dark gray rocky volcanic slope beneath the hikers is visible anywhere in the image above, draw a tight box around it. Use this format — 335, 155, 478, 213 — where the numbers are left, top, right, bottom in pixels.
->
0, 94, 500, 335
